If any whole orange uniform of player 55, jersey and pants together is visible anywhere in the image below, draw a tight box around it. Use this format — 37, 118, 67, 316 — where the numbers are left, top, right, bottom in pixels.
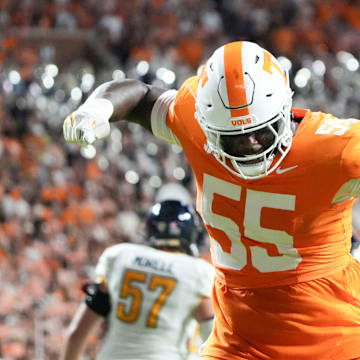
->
152, 77, 360, 360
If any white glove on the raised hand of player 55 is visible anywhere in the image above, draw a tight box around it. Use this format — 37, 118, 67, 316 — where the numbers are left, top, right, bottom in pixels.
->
63, 98, 114, 146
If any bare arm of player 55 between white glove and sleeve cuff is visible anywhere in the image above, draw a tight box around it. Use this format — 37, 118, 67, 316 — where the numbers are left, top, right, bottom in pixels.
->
87, 79, 164, 130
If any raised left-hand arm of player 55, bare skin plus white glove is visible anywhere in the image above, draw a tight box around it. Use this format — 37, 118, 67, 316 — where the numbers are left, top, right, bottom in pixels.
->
63, 79, 166, 145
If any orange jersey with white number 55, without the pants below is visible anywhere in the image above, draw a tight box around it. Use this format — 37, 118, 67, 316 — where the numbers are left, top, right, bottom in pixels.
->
161, 77, 360, 288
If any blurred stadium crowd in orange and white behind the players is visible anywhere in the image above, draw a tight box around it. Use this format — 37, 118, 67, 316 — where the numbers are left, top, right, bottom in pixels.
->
0, 0, 360, 360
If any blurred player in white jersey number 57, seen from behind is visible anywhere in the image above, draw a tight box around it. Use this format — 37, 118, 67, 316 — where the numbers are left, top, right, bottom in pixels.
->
63, 200, 214, 360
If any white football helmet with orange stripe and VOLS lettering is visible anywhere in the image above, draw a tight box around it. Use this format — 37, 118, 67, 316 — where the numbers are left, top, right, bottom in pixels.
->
195, 41, 293, 179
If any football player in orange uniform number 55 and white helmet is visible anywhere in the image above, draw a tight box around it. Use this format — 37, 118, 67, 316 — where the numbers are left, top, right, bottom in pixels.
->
63, 42, 360, 360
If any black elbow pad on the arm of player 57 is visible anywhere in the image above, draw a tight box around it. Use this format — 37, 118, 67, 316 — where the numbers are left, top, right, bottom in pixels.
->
82, 283, 111, 317
